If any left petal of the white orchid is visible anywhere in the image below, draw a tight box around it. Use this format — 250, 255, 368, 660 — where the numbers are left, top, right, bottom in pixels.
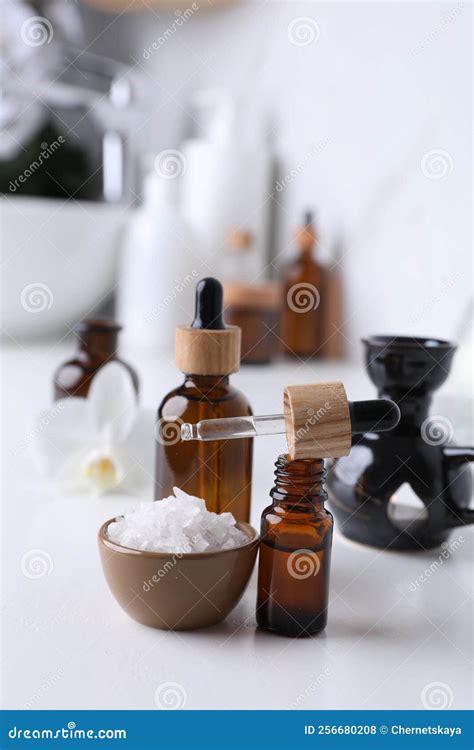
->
31, 398, 93, 475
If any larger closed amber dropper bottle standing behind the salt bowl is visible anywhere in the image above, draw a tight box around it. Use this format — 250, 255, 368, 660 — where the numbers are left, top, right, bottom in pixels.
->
155, 278, 253, 521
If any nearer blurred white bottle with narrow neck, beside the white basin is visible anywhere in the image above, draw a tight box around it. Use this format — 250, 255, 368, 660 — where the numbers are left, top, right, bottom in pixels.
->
117, 171, 198, 353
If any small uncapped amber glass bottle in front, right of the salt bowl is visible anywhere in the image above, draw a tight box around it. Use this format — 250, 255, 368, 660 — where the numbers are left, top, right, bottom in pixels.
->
257, 455, 333, 637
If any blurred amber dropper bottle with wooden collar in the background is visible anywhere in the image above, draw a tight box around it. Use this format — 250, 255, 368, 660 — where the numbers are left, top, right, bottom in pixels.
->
281, 212, 324, 358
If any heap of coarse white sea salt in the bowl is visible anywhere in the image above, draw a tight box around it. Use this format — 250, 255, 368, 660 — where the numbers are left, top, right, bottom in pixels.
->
107, 487, 248, 554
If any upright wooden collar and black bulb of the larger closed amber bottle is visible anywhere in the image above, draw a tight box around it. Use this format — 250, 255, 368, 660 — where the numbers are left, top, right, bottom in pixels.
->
175, 277, 240, 375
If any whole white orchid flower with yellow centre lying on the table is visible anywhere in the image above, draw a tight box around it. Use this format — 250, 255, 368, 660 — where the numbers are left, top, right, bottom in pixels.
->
33, 362, 155, 495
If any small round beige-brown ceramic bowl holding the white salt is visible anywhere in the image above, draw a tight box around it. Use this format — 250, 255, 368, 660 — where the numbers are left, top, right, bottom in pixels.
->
99, 518, 258, 630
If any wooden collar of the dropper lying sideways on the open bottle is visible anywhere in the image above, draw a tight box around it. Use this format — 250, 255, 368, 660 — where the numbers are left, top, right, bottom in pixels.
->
283, 381, 352, 460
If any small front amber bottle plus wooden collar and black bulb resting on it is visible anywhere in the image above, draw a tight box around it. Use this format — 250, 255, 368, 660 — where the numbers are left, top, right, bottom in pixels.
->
257, 383, 400, 637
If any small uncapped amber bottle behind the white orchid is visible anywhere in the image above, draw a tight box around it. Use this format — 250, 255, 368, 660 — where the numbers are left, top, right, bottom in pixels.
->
54, 320, 138, 399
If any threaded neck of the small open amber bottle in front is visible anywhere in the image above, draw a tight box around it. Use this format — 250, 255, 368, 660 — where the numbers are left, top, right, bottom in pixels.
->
270, 454, 327, 508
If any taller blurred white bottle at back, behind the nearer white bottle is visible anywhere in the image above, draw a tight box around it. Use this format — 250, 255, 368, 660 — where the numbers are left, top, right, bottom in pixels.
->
182, 91, 272, 280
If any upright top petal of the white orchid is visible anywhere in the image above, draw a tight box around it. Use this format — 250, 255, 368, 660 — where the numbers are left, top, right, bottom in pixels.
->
87, 362, 137, 442
